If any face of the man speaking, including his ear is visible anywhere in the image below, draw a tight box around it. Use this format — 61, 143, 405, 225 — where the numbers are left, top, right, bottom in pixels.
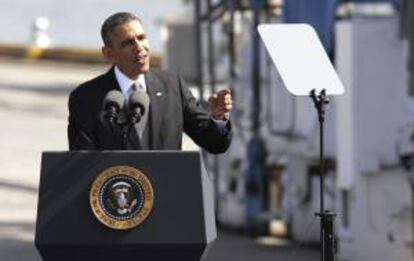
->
102, 21, 150, 79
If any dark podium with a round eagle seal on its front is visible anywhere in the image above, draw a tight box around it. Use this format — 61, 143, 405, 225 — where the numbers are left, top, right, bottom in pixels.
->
35, 151, 216, 261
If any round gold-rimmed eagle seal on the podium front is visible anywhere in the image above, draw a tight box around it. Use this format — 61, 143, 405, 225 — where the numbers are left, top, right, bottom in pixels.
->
89, 166, 154, 230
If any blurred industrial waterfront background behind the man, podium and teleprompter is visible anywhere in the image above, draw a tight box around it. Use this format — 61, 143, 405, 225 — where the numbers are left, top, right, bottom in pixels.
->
0, 0, 414, 261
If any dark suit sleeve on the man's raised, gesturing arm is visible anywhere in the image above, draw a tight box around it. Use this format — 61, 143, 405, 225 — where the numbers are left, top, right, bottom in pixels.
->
178, 74, 232, 154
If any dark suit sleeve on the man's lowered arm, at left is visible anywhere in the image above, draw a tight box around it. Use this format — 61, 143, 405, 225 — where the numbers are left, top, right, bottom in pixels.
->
68, 92, 97, 150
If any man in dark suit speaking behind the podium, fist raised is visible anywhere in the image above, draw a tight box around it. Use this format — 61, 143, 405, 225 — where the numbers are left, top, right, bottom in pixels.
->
68, 13, 232, 153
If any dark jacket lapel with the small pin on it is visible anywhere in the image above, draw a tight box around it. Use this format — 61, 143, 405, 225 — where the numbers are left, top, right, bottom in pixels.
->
145, 71, 166, 149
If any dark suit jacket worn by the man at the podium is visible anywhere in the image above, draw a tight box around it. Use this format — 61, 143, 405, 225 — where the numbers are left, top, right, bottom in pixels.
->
68, 67, 232, 153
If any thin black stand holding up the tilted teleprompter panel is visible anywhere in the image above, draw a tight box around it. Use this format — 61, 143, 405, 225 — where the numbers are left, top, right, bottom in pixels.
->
310, 89, 336, 261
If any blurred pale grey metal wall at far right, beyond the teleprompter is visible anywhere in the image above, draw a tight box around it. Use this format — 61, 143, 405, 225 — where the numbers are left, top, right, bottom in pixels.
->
336, 17, 414, 261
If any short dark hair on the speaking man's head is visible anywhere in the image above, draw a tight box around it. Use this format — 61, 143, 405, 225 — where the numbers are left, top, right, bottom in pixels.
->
101, 12, 141, 46
